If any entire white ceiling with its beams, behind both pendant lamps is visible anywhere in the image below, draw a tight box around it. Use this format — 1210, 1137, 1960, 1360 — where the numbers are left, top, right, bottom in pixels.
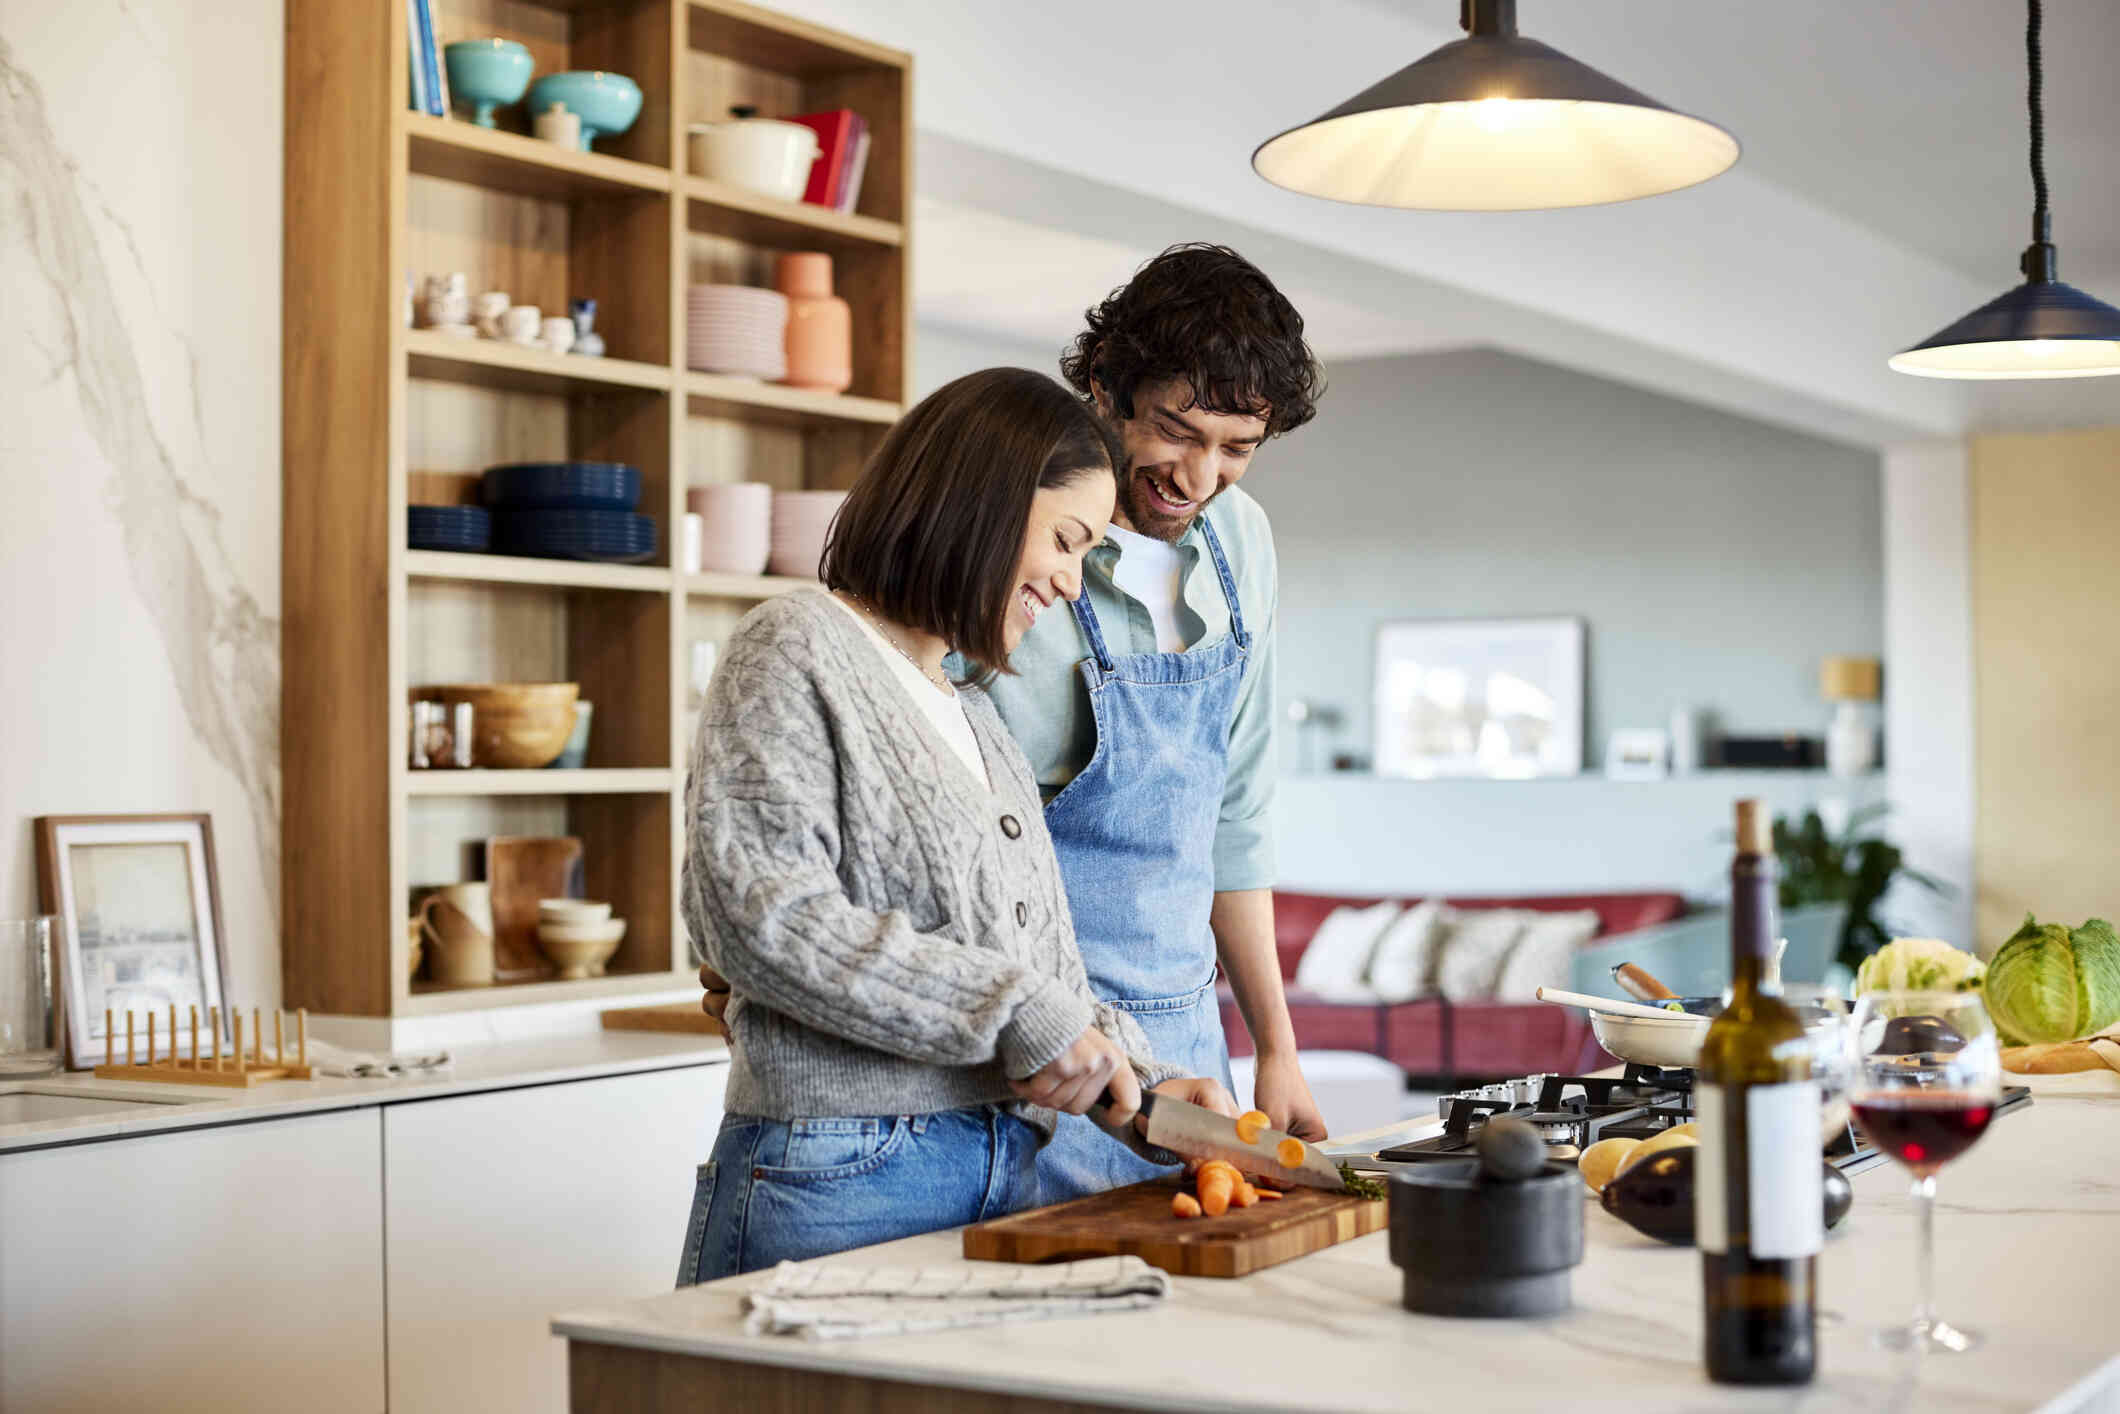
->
778, 0, 2120, 445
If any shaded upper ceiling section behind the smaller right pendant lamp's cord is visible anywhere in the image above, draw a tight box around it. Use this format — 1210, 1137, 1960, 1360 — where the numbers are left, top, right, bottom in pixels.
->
1458, 0, 2120, 292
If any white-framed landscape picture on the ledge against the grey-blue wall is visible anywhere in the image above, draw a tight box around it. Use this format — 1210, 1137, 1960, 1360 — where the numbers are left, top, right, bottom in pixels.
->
1374, 617, 1586, 780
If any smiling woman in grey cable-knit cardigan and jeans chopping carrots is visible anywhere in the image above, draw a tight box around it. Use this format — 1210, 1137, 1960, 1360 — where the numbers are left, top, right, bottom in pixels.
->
678, 369, 1236, 1285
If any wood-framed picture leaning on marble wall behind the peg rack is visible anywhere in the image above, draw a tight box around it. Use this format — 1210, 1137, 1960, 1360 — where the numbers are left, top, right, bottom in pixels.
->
36, 814, 231, 1071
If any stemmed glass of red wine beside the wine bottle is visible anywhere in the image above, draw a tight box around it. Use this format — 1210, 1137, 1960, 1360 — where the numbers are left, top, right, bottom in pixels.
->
1849, 990, 2001, 1355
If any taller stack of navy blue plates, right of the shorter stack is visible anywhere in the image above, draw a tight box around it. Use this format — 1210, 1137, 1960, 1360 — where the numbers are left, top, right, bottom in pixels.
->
479, 462, 655, 564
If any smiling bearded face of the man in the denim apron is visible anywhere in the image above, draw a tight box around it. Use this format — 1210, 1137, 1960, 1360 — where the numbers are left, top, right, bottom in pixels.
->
1098, 382, 1266, 541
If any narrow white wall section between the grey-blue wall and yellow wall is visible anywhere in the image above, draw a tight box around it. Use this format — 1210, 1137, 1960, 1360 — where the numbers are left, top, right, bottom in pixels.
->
1885, 443, 1993, 948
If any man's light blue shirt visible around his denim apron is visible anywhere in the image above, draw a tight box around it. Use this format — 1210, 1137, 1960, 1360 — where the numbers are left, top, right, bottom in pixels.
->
986, 485, 1280, 892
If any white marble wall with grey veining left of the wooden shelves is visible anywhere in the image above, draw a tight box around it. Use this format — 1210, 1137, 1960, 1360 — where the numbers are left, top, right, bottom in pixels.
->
0, 0, 282, 1005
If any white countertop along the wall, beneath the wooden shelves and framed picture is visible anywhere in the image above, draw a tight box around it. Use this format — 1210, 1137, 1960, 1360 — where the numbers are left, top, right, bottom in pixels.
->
0, 1030, 729, 1153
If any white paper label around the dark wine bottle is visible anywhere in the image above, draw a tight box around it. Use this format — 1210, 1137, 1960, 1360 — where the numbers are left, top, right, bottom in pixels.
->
1694, 1081, 1825, 1257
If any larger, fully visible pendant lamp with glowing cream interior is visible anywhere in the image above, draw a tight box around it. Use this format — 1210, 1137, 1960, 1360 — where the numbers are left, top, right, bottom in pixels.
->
1251, 0, 1738, 212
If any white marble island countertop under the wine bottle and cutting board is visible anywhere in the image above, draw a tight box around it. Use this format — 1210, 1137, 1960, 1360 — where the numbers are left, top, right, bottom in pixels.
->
553, 1096, 2120, 1414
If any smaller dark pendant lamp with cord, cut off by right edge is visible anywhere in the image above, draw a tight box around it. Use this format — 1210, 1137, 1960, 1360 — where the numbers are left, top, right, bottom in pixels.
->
1889, 0, 2120, 379
